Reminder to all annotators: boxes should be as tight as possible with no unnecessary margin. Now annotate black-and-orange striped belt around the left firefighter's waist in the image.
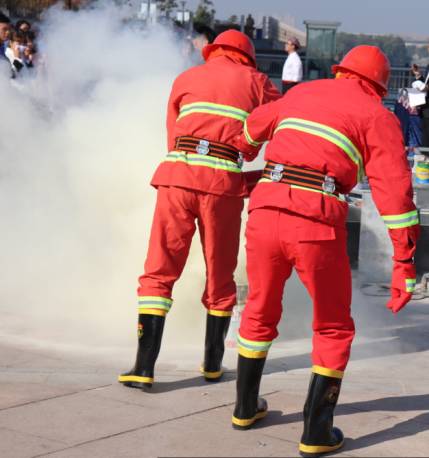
[176,136,241,164]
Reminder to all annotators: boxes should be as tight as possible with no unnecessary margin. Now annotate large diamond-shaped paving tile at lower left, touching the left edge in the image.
[0,391,164,445]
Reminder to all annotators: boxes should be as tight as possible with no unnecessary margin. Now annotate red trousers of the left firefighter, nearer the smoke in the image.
[138,186,243,316]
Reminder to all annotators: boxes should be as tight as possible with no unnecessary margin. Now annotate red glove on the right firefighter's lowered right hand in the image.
[386,261,416,313]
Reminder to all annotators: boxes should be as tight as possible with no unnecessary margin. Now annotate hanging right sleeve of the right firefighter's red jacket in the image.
[365,110,420,262]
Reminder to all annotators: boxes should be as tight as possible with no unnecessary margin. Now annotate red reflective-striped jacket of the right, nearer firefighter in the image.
[234,78,419,260]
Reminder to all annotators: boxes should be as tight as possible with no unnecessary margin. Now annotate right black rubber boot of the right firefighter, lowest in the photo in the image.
[299,373,344,457]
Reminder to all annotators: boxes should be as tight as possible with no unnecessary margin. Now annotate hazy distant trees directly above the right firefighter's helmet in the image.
[337,32,410,67]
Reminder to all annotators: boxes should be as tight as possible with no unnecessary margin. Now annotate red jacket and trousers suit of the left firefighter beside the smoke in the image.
[138,49,280,316]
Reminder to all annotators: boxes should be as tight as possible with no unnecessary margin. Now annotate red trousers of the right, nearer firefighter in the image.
[238,208,355,377]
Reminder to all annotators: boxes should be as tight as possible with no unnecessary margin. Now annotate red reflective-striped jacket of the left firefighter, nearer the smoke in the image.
[151,56,281,196]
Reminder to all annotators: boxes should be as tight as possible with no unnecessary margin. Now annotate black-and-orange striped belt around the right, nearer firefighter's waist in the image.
[262,161,339,196]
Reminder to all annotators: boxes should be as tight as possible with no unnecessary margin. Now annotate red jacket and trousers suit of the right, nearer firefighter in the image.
[235,79,419,377]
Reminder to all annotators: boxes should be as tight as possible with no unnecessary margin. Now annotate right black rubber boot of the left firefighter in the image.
[201,314,231,382]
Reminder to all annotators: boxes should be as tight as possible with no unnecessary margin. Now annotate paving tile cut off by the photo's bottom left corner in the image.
[0,428,64,458]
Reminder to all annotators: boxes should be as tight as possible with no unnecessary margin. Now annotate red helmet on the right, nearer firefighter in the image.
[332,45,390,95]
